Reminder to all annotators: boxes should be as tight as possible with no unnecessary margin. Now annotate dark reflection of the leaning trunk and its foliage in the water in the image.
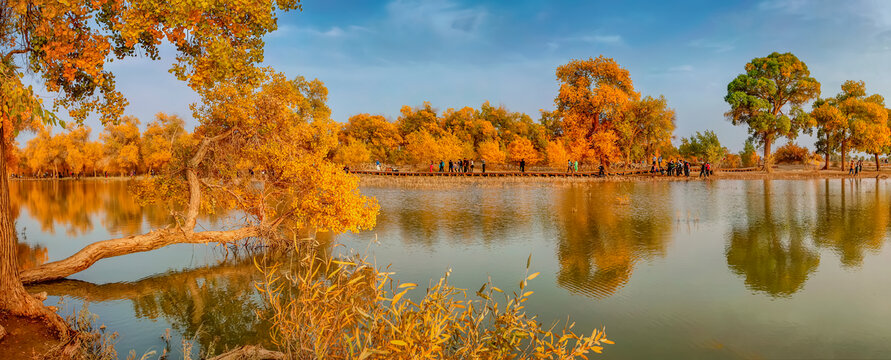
[28,257,270,349]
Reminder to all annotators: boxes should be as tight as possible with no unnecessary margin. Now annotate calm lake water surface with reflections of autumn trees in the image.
[11,179,891,359]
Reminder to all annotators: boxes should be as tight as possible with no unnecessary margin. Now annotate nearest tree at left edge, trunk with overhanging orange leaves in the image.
[0,0,300,335]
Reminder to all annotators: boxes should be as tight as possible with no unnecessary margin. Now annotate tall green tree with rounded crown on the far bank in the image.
[724,52,820,172]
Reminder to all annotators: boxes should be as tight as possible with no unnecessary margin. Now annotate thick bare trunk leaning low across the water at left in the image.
[20,226,260,284]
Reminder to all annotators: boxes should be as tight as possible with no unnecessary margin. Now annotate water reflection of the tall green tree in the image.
[726,180,820,296]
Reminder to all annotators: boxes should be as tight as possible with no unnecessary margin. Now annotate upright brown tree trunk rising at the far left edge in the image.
[0,126,68,337]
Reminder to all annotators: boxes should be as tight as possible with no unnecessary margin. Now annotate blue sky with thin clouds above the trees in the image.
[22,0,891,150]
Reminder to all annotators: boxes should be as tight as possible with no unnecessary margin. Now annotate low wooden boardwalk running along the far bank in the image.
[349,167,757,178]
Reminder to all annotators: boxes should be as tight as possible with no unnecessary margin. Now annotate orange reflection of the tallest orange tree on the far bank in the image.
[554,183,672,298]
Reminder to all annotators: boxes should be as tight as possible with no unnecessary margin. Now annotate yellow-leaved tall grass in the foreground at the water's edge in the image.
[256,240,613,359]
